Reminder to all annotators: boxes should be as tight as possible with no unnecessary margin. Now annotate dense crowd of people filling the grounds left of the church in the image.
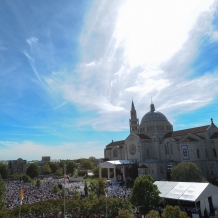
[5,178,131,210]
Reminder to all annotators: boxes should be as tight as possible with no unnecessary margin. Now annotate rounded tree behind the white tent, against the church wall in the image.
[171,162,202,182]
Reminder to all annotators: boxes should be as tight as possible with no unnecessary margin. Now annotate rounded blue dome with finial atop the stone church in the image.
[140,103,169,125]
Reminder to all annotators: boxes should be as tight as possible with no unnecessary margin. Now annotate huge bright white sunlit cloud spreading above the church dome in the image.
[43,0,218,130]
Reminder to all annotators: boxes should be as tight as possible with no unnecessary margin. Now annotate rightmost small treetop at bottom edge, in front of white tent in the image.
[161,205,189,218]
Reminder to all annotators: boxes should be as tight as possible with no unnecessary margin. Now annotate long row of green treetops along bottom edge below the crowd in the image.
[6,197,132,218]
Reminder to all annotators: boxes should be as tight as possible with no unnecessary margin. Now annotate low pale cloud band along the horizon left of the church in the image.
[0,141,103,160]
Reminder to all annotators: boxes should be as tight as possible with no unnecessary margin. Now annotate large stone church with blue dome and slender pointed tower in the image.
[104,102,218,180]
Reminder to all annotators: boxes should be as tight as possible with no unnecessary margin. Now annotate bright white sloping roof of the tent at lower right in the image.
[154,181,218,202]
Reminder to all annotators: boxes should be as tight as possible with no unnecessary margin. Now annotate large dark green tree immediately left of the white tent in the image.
[130,175,161,214]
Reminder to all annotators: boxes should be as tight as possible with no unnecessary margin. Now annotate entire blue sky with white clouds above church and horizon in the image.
[0,0,218,160]
